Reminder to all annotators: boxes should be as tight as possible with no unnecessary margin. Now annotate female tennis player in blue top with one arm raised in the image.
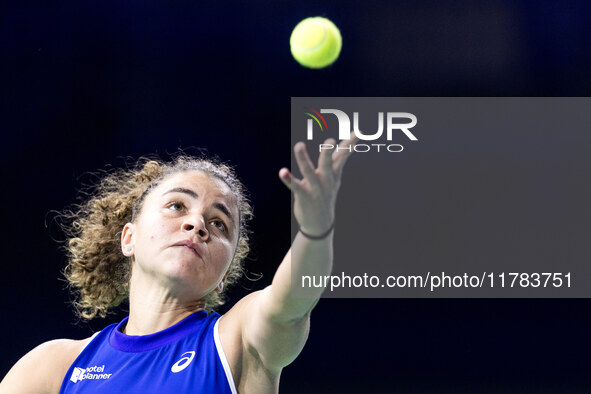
[0,139,353,394]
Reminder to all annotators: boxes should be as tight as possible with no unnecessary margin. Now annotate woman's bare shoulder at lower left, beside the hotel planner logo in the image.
[0,337,92,394]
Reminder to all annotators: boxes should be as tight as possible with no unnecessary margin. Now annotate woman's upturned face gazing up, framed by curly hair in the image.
[122,171,239,299]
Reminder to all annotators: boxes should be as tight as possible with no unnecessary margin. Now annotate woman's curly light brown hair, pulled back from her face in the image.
[61,155,252,320]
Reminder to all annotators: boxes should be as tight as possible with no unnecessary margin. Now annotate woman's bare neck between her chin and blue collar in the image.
[123,275,205,335]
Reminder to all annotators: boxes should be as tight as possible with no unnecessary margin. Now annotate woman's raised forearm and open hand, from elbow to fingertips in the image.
[263,136,355,322]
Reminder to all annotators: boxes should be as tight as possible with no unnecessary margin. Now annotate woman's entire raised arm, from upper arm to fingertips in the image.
[234,139,354,374]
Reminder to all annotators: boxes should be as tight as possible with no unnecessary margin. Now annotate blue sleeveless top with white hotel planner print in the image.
[60,311,236,394]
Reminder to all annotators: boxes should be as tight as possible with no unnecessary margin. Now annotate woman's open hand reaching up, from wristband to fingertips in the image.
[279,133,357,236]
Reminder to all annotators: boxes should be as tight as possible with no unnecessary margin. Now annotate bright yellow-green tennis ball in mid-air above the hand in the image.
[289,17,343,68]
